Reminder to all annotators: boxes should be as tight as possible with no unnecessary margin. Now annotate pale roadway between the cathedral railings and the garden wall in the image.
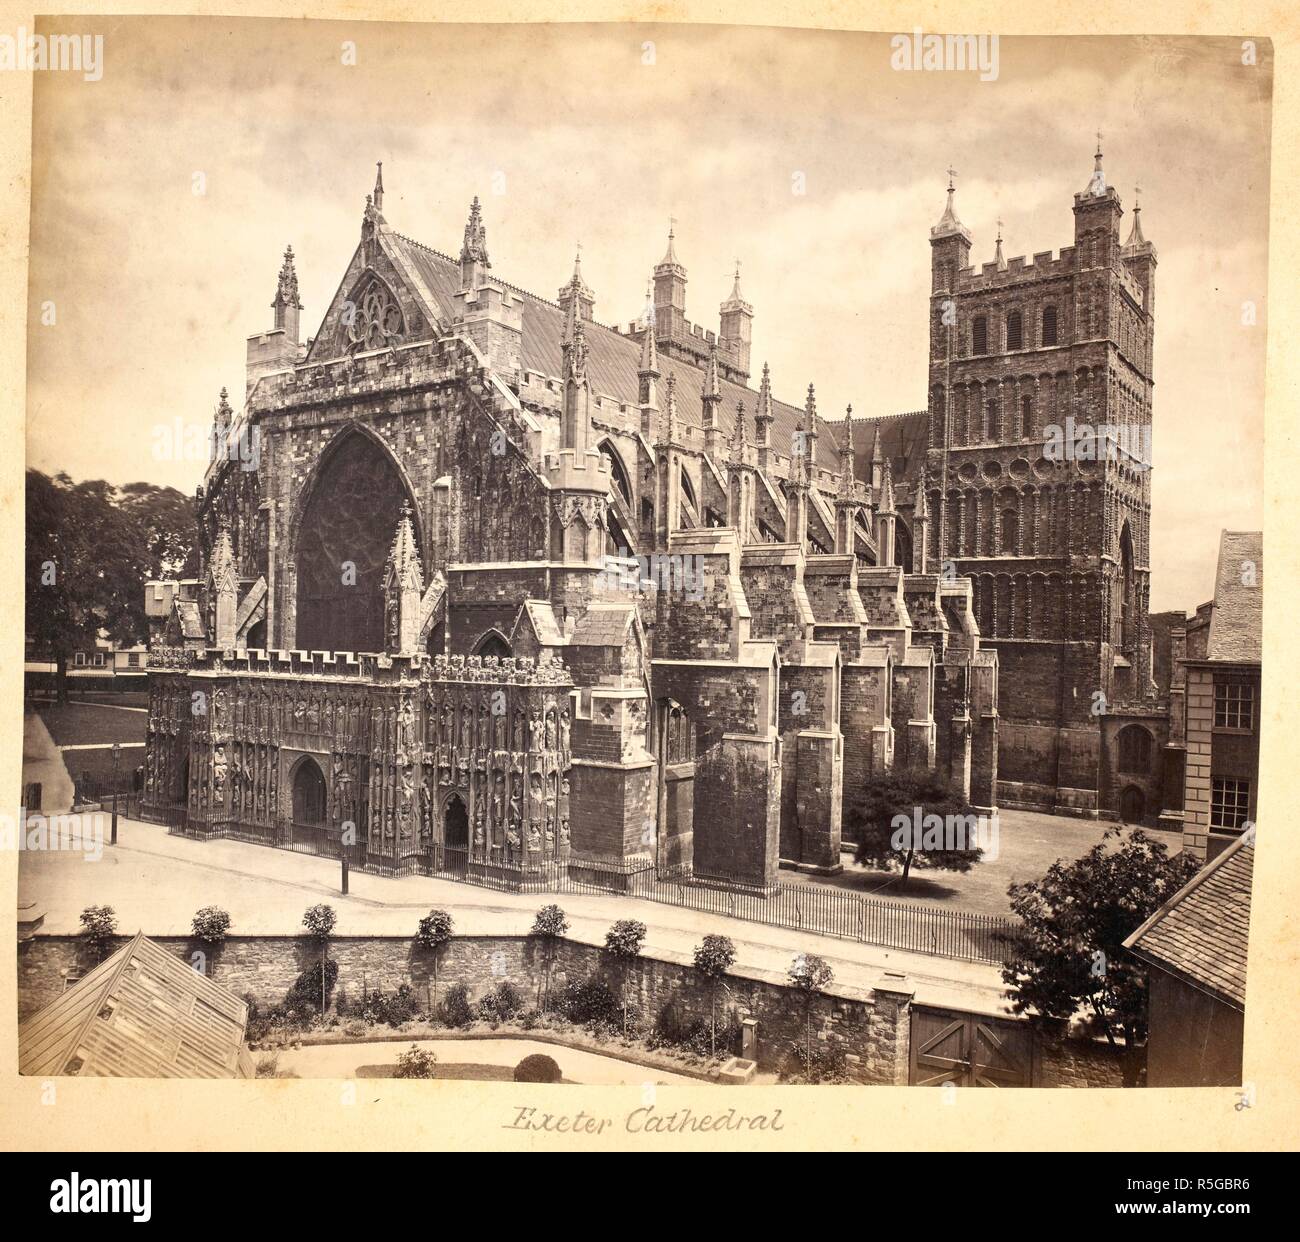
[18,817,1004,1013]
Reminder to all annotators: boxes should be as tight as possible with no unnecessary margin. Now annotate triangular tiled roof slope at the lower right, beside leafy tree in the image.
[1125,835,1255,1009]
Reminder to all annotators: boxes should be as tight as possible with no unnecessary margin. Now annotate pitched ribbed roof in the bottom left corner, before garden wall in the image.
[18,934,251,1078]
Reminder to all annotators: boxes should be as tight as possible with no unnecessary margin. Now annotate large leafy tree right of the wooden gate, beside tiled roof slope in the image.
[1002,826,1196,1083]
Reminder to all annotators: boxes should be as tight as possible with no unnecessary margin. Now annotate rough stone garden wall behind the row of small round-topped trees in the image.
[18,935,1121,1086]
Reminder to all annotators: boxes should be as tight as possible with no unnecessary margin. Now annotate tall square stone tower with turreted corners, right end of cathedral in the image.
[924,145,1156,812]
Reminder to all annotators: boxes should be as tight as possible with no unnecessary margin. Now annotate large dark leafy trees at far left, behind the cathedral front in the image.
[25,469,198,702]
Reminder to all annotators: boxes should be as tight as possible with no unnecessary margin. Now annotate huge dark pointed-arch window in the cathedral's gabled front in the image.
[294,430,408,653]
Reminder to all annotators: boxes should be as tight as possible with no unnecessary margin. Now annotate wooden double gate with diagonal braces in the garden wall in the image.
[907,1005,1035,1087]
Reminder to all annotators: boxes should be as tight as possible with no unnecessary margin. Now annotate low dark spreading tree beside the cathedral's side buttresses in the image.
[845,769,983,888]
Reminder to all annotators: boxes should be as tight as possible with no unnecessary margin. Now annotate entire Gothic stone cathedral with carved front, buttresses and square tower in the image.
[143,151,1160,892]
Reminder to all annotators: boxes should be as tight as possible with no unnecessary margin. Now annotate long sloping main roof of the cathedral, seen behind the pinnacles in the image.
[393,233,840,471]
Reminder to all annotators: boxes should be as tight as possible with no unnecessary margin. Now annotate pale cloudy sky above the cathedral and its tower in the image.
[29,18,1271,609]
